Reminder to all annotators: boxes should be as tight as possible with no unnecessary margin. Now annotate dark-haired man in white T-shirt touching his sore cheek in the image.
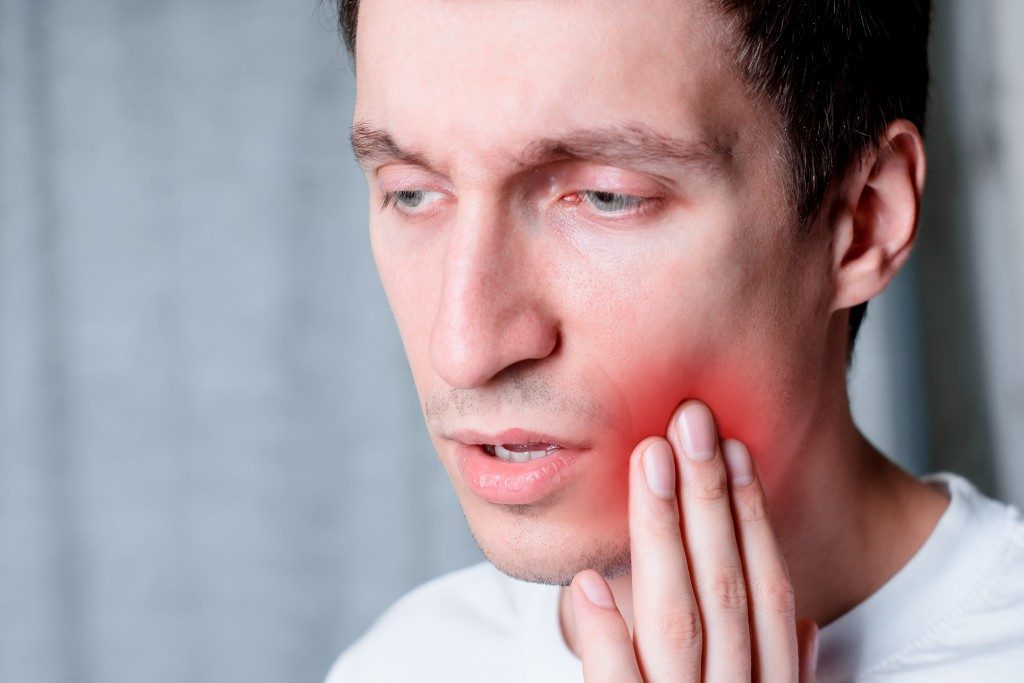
[329,0,1024,683]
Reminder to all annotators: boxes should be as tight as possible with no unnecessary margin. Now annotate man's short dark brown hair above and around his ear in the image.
[337,0,932,366]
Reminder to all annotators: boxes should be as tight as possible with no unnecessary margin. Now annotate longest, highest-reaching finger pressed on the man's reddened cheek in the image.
[669,400,752,681]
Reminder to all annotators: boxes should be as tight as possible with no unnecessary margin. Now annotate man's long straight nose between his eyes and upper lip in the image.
[430,200,558,389]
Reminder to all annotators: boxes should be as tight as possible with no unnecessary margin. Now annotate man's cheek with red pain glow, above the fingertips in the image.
[578,232,795,462]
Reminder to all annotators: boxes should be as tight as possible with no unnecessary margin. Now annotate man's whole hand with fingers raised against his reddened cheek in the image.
[571,400,817,683]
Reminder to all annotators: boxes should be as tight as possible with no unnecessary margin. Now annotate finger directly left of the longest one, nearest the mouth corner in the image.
[630,437,701,683]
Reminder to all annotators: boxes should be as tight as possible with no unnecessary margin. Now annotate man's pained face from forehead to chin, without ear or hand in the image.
[354,0,835,584]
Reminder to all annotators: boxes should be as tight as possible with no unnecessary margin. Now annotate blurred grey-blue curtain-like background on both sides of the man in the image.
[0,0,1024,683]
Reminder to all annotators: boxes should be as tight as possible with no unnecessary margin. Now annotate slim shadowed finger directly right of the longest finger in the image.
[722,439,799,681]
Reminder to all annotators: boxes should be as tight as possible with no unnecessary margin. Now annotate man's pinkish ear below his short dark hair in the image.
[830,120,926,311]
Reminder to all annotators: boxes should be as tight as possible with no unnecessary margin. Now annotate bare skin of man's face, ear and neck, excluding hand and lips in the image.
[353,0,946,667]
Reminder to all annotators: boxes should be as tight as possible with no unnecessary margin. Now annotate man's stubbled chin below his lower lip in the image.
[467,506,630,586]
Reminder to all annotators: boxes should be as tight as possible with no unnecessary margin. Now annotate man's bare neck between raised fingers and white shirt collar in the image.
[559,391,948,653]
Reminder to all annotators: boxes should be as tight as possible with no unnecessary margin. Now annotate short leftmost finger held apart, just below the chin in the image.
[570,569,643,683]
